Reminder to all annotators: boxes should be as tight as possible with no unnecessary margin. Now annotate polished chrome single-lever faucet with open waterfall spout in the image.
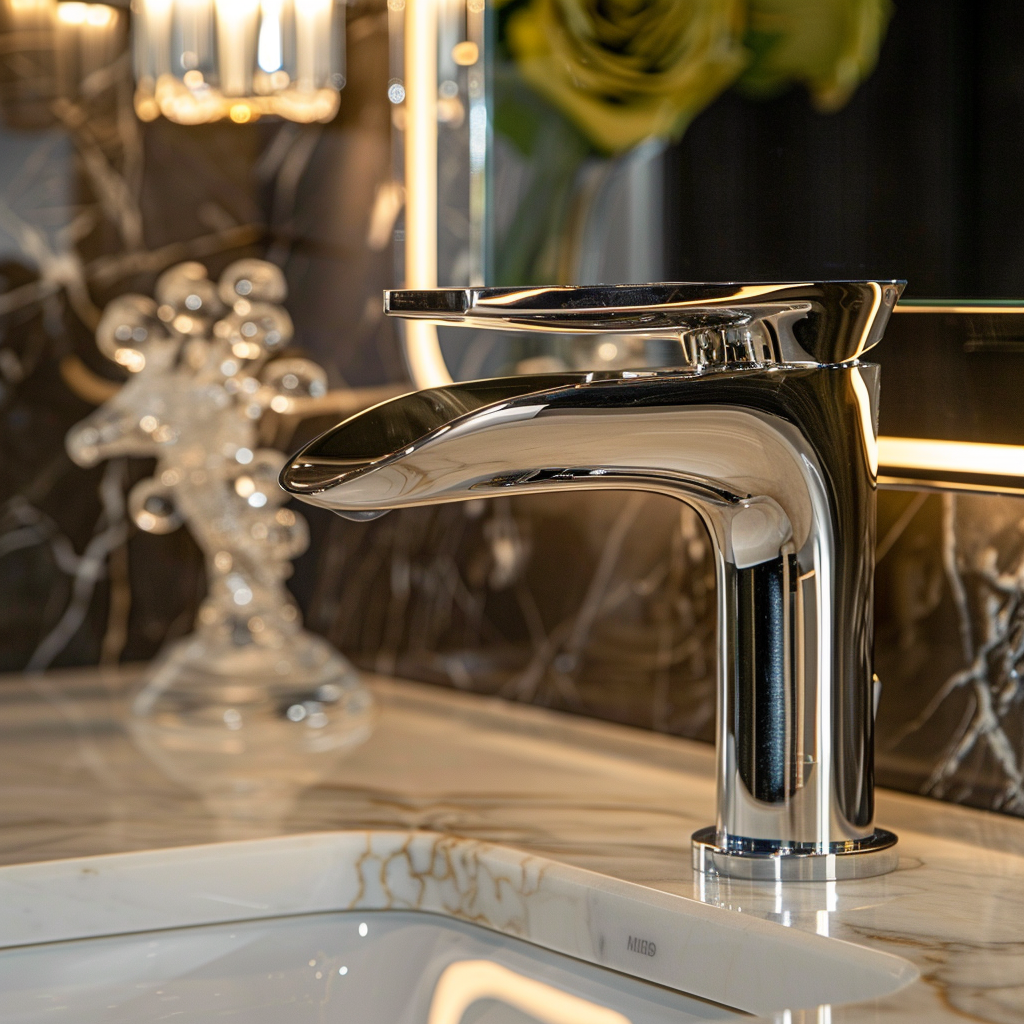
[281,281,903,881]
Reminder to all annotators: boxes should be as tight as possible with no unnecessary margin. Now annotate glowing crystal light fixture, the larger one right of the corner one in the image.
[132,0,345,124]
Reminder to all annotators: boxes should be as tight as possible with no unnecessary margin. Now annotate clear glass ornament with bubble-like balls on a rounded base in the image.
[68,259,372,818]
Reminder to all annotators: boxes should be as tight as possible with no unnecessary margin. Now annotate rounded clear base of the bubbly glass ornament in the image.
[129,615,374,822]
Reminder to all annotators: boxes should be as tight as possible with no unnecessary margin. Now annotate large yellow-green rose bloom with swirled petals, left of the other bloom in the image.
[506,0,749,154]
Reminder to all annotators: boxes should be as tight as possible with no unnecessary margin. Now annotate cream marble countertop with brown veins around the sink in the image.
[0,671,1024,1024]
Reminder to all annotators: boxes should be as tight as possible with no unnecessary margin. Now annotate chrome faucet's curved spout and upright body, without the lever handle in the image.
[282,365,892,877]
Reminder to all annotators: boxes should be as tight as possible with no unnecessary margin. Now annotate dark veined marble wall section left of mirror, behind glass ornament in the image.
[0,0,404,670]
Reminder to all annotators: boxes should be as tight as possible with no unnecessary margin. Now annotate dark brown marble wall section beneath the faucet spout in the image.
[309,494,715,739]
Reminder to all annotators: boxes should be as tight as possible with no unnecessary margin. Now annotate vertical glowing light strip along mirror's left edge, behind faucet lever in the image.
[404,0,452,388]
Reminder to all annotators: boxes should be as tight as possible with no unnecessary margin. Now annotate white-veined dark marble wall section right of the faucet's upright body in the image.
[876,493,1024,814]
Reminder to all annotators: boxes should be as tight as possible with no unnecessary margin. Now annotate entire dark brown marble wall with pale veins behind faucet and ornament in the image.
[0,0,1024,814]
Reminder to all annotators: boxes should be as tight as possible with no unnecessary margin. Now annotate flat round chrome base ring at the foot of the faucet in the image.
[692,826,899,882]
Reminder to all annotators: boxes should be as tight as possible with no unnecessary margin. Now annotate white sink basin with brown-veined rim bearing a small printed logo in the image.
[0,833,918,1024]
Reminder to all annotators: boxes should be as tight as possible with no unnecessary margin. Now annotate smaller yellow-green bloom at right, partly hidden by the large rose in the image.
[740,0,892,112]
